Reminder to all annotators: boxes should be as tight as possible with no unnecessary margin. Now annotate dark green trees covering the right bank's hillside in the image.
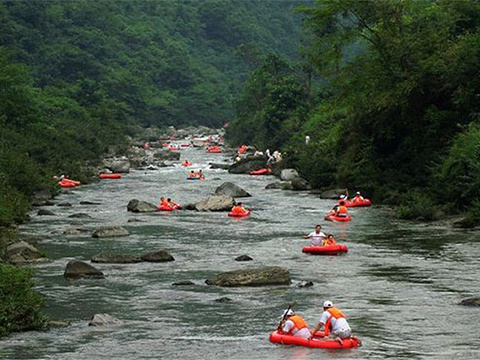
[229,0,480,226]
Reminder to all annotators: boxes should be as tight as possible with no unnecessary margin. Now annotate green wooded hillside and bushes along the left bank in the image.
[0,0,302,336]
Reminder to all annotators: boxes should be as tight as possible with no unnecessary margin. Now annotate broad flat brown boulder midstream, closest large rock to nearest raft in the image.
[205,266,291,287]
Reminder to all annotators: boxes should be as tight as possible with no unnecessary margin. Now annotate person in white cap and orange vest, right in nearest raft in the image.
[310,300,360,345]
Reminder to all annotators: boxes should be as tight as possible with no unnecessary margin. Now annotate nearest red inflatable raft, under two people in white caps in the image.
[270,330,360,349]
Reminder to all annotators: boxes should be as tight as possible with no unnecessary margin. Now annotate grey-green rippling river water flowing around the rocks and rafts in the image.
[0,148,480,360]
